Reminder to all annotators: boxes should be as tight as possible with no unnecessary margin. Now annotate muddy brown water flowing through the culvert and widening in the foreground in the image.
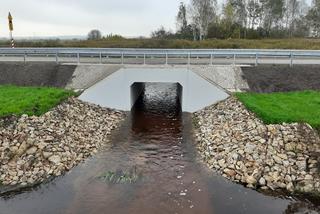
[0,84,317,214]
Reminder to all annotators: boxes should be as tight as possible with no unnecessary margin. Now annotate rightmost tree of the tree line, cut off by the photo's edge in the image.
[307,0,320,37]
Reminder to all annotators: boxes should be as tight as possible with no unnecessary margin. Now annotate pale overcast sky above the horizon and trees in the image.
[0,0,310,37]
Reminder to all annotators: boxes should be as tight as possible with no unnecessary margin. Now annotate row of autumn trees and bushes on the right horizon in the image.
[151,0,320,40]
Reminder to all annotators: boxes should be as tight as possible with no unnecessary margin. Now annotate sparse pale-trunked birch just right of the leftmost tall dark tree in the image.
[189,0,217,40]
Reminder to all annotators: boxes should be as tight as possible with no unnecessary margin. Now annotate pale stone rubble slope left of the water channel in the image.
[0,98,124,186]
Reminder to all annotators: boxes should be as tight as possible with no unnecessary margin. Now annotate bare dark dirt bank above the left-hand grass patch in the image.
[0,62,76,88]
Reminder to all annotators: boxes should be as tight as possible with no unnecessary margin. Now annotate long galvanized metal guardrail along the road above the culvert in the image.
[0,48,320,66]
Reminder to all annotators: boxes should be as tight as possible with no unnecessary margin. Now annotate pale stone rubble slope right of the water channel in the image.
[194,97,320,193]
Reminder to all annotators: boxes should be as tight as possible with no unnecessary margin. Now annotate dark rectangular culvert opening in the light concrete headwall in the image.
[131,82,183,117]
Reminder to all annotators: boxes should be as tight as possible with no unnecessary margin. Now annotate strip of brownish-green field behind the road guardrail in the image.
[0,38,320,50]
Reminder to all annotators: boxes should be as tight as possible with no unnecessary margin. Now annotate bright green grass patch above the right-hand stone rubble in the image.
[236,91,320,130]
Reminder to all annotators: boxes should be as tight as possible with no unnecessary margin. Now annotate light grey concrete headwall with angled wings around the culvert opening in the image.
[80,67,228,112]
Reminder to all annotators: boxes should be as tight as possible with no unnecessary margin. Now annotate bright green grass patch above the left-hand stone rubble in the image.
[0,86,75,117]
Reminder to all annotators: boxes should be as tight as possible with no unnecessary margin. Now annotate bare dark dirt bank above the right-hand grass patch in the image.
[242,65,320,93]
